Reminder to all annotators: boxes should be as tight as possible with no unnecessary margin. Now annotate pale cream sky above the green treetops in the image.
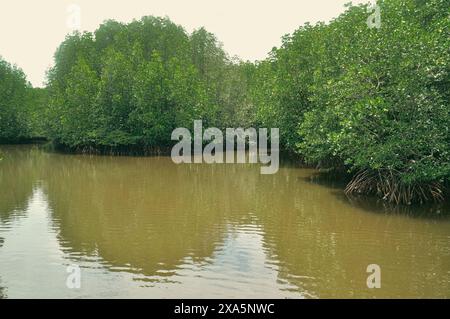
[0,0,368,86]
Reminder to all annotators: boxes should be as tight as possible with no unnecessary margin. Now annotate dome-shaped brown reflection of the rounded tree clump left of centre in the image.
[45,156,262,275]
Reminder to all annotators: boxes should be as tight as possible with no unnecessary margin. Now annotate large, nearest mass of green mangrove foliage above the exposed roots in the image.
[251,0,450,202]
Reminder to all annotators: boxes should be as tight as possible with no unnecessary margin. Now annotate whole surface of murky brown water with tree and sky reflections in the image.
[0,146,450,298]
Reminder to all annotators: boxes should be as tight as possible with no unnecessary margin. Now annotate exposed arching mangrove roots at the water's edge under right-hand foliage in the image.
[345,170,444,205]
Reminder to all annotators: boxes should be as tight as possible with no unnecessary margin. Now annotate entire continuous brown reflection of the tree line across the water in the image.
[0,146,450,297]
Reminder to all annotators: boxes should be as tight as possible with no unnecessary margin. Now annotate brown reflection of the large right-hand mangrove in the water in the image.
[253,171,450,297]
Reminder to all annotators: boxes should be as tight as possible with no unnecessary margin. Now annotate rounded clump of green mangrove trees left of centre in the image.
[47,17,253,148]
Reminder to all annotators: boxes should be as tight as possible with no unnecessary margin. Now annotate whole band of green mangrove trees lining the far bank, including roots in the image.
[0,0,450,203]
